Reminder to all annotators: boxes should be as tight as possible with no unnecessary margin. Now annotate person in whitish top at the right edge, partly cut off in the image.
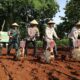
[68,21,80,58]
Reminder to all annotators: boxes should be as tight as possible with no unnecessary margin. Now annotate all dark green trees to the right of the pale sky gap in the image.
[58,0,80,37]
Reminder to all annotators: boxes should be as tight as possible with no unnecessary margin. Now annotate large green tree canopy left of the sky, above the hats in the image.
[0,0,59,38]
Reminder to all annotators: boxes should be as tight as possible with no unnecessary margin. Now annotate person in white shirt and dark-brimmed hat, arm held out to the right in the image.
[45,20,59,62]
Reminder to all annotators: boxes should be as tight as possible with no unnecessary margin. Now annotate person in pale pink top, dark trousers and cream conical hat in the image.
[25,20,39,56]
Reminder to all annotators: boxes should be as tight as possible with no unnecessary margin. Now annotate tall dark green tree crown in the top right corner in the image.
[65,0,80,25]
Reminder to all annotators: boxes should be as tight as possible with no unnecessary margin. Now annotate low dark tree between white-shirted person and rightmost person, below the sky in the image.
[57,17,72,38]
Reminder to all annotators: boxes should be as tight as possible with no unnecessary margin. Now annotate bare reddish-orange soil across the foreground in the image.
[0,49,80,80]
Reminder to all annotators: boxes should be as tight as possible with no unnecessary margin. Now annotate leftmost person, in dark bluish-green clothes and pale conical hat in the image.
[7,23,19,56]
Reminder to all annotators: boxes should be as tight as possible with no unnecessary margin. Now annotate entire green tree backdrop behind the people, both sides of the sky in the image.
[0,0,80,45]
